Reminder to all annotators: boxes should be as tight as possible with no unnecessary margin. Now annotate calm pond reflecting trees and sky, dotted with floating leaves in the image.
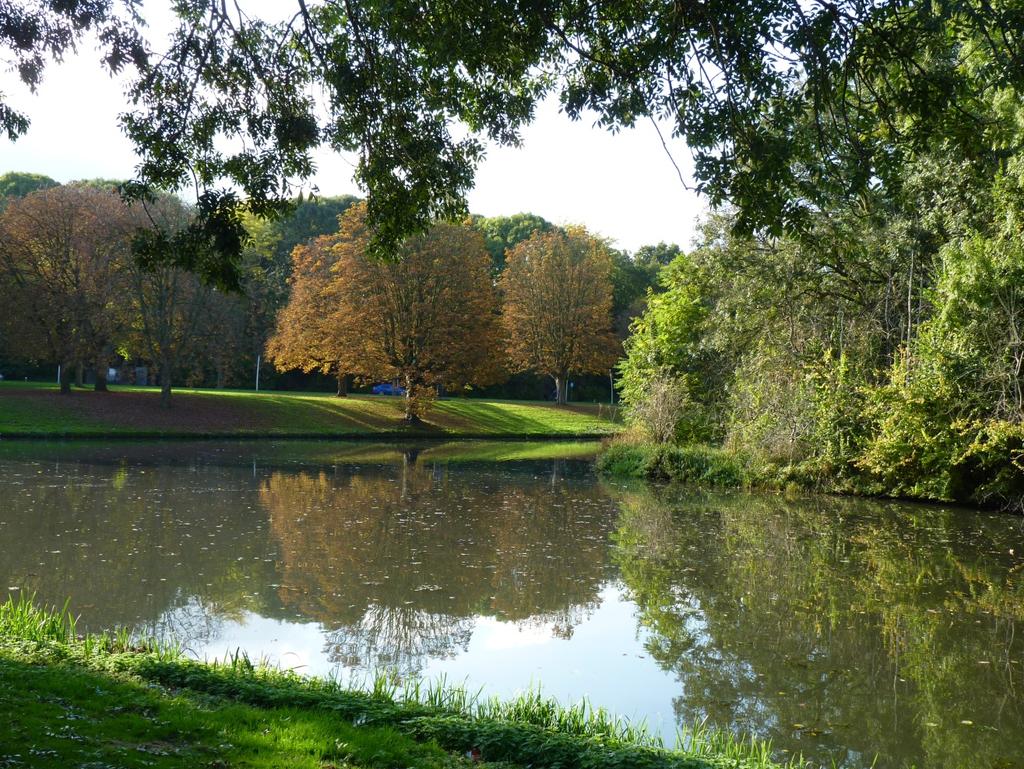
[0,443,1024,769]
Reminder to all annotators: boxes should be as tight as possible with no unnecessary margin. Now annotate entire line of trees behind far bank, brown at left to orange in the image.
[0,173,667,411]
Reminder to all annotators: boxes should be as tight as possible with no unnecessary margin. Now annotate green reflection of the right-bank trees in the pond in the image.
[615,492,1024,768]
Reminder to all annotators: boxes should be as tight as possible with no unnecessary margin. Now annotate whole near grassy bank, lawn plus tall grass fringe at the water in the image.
[0,599,804,769]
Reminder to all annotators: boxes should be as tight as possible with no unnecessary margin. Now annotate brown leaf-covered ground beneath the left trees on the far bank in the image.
[0,390,268,433]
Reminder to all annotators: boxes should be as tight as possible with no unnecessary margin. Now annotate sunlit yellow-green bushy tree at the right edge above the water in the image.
[859,208,1024,510]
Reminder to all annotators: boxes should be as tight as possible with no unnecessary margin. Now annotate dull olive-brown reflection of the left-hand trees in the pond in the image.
[0,463,273,643]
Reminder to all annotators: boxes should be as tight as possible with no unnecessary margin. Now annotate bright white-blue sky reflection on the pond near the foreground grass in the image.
[177,584,679,741]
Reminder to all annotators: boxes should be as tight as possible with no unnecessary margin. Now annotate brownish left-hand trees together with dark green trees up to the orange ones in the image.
[0,172,376,400]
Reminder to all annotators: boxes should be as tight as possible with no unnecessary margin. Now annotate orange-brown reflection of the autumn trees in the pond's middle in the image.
[260,460,614,671]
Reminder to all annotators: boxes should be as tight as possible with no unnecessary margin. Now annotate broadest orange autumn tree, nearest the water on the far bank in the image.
[267,204,504,422]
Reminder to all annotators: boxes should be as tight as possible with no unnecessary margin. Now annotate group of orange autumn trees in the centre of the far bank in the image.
[267,204,618,421]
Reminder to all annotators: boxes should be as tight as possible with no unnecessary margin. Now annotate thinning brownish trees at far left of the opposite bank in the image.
[0,181,235,402]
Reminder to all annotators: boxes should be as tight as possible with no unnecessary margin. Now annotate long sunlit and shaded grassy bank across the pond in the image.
[0,382,618,438]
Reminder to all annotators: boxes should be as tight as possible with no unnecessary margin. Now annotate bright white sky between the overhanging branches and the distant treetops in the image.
[0,19,705,251]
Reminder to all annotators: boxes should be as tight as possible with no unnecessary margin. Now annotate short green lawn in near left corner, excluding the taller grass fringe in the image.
[0,651,491,769]
